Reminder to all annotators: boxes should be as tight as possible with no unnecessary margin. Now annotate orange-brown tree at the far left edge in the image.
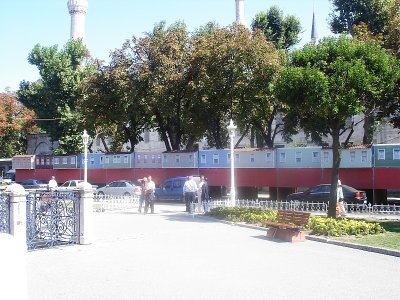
[0,93,39,157]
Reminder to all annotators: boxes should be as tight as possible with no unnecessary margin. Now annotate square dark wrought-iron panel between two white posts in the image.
[26,191,80,250]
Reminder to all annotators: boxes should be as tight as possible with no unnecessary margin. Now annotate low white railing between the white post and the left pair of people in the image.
[93,194,139,212]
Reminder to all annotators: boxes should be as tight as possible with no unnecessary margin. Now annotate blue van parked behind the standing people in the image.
[155,176,200,202]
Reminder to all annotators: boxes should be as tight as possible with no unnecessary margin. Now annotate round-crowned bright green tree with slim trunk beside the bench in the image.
[276,36,399,217]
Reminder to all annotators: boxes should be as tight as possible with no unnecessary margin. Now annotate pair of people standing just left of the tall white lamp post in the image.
[183,176,210,213]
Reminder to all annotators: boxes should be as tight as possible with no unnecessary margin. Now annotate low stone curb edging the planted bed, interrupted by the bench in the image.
[196,216,400,257]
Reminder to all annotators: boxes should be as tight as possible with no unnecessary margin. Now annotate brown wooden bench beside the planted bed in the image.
[263,210,310,242]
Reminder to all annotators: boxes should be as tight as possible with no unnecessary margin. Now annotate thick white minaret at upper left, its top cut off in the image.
[67,0,88,40]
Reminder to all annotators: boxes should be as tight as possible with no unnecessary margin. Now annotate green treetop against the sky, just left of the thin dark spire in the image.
[251,6,301,50]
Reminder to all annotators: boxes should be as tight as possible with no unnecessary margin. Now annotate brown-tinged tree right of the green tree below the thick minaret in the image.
[82,49,152,152]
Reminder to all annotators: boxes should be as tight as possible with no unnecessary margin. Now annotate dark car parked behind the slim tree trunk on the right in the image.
[286,184,367,204]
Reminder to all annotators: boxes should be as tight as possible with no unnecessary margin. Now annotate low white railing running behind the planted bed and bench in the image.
[197,200,400,215]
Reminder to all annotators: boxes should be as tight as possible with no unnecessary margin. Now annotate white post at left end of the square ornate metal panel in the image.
[6,183,28,249]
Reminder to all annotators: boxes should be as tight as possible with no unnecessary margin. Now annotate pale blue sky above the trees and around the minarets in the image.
[0,0,331,92]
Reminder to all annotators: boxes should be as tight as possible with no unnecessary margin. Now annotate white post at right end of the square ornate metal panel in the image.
[78,183,94,245]
